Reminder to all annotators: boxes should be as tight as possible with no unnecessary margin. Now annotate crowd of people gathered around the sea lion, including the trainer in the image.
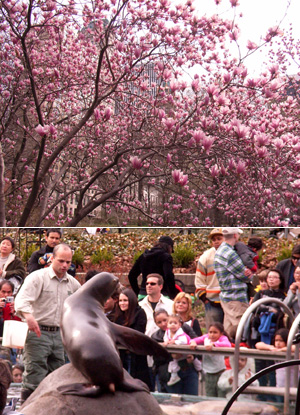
[0,231,300,413]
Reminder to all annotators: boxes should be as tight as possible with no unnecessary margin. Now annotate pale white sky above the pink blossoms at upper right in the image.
[194,0,300,74]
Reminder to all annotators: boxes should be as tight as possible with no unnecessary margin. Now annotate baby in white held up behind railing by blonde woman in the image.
[164,314,190,386]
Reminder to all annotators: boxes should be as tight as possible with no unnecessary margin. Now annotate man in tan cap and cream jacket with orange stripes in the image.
[195,228,224,329]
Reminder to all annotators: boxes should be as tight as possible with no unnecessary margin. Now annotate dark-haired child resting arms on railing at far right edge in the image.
[255,328,297,402]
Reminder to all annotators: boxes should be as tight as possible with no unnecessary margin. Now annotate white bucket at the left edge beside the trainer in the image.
[2,320,28,349]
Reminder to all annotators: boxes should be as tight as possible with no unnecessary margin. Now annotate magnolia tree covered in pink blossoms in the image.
[0,0,300,226]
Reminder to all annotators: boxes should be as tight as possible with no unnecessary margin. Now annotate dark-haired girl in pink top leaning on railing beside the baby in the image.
[190,322,231,396]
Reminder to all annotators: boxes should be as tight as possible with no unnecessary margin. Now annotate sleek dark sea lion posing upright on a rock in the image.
[59,272,168,396]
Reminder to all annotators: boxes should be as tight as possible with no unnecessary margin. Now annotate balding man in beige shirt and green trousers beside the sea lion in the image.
[15,244,80,403]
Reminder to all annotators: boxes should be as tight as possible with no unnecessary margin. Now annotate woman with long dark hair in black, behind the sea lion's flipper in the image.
[114,288,151,388]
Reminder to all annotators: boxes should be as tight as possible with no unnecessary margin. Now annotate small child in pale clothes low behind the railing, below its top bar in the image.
[218,347,259,401]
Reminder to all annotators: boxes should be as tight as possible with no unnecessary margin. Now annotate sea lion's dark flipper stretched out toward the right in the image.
[111,323,169,358]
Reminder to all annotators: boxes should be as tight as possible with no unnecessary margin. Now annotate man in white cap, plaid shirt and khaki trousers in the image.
[214,227,252,338]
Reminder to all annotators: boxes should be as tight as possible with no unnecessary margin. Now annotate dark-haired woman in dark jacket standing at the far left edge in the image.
[0,236,26,294]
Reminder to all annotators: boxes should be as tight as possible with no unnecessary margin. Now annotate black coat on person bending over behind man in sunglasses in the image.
[128,247,178,299]
